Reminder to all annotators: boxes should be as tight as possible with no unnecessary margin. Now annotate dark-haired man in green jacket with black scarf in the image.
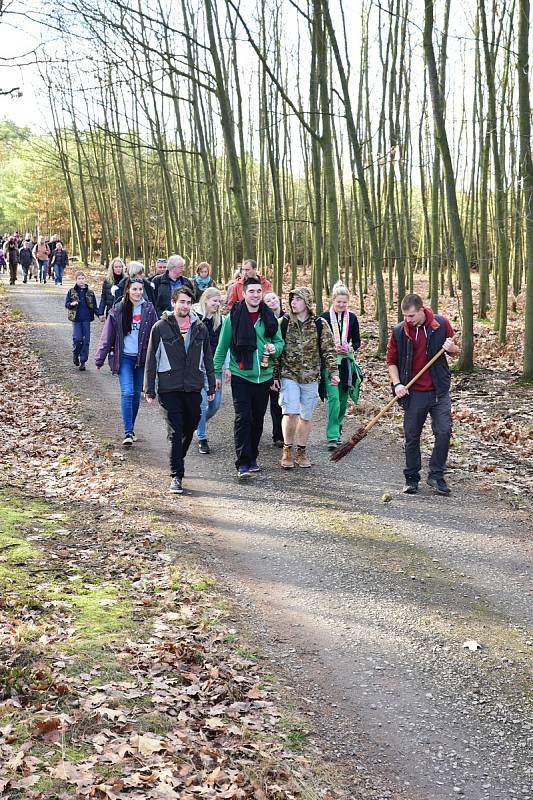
[215,277,283,479]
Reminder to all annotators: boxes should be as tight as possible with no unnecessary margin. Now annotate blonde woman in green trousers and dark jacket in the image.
[322,282,362,450]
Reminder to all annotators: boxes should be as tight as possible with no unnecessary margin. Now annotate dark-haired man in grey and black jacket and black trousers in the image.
[144,286,215,494]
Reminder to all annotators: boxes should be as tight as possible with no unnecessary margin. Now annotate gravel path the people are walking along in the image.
[11,276,533,800]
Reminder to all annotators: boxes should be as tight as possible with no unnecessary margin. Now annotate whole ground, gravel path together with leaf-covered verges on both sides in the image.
[0,270,533,800]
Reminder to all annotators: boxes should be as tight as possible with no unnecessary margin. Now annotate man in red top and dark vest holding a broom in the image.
[387,294,460,495]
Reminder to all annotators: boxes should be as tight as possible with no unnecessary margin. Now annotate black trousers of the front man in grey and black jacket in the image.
[159,392,202,478]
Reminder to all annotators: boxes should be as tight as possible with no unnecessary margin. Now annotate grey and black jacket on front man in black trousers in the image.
[144,312,215,397]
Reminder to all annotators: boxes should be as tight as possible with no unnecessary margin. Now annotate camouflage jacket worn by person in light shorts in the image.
[279,314,339,383]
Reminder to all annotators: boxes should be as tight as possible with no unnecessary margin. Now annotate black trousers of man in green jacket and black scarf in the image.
[231,375,271,469]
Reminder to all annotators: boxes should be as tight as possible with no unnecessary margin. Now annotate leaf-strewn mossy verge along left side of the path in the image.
[0,297,344,800]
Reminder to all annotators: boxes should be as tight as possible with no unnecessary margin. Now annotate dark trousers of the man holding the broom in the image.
[403,390,452,481]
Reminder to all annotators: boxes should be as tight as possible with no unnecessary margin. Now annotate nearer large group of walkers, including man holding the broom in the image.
[2,237,459,495]
